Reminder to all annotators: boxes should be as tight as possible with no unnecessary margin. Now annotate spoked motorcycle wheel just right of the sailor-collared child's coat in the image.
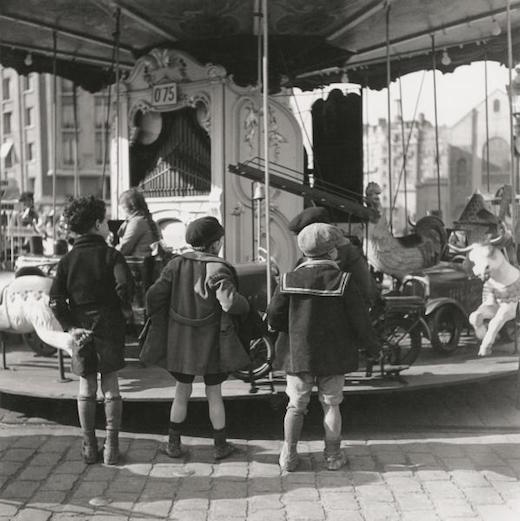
[379,317,422,365]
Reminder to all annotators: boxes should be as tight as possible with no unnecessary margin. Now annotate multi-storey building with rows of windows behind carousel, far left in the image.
[0,69,111,211]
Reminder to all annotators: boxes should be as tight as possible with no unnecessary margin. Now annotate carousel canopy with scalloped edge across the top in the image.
[0,0,520,91]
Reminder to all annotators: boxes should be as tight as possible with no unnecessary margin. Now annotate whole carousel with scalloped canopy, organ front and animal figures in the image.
[0,0,520,401]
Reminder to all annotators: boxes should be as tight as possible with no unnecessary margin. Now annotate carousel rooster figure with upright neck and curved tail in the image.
[365,182,447,279]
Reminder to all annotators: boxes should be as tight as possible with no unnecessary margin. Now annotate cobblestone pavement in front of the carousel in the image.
[0,378,520,521]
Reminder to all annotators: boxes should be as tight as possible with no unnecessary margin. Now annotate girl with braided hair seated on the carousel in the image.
[116,188,161,257]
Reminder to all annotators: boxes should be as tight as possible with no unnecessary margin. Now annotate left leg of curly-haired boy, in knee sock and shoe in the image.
[78,373,98,464]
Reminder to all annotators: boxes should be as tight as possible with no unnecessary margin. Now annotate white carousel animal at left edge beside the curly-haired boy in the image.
[0,275,74,355]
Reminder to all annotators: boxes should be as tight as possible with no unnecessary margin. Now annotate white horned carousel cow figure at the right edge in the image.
[450,237,520,356]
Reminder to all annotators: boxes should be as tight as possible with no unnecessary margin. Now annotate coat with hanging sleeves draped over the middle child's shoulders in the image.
[141,251,249,376]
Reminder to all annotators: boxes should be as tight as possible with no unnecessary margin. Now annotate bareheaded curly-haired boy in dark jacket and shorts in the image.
[50,196,133,465]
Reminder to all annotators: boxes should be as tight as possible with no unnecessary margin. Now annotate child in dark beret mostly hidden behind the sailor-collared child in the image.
[289,206,378,306]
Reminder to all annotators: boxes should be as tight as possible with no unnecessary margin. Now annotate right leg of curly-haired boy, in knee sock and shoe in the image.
[101,371,123,465]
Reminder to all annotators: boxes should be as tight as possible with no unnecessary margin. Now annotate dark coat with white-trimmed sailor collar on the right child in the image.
[268,260,379,376]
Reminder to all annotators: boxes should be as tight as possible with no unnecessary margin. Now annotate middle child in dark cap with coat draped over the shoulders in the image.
[143,217,249,460]
